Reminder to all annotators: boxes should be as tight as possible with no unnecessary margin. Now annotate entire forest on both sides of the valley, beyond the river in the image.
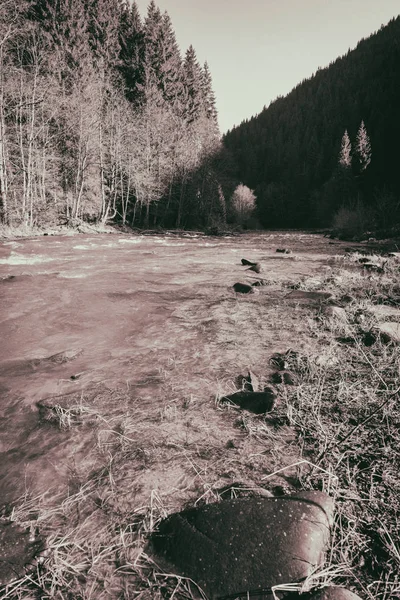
[0,0,400,229]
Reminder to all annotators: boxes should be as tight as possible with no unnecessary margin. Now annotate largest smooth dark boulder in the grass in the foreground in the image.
[147,491,334,600]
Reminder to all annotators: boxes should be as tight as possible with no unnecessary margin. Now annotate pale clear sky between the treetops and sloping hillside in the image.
[136,0,400,133]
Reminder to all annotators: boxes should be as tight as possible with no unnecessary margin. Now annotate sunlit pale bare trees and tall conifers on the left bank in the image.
[0,0,239,227]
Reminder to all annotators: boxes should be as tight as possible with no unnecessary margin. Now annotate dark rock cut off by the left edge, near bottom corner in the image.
[0,520,45,585]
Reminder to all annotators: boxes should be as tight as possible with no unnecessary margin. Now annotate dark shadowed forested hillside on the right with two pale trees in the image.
[223,17,400,229]
